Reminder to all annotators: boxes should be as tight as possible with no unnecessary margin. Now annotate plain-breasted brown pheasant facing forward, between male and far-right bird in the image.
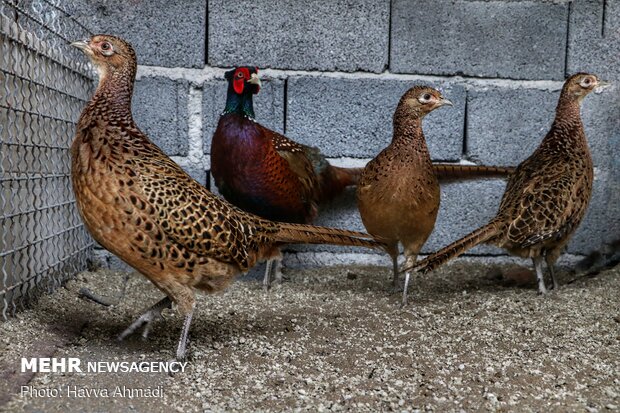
[357,86,452,306]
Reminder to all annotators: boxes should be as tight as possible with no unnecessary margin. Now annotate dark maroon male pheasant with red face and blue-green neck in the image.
[211,66,513,289]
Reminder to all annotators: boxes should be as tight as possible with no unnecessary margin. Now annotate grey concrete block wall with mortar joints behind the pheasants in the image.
[70,0,620,268]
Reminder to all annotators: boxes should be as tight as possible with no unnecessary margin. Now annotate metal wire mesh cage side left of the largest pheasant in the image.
[0,0,94,319]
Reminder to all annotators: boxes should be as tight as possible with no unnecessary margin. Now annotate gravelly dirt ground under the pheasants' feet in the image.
[0,262,620,412]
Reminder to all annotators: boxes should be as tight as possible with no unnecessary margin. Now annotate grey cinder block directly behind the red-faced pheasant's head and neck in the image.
[202,77,284,153]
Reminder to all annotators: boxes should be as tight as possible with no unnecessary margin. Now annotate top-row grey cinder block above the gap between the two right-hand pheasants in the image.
[390,0,568,79]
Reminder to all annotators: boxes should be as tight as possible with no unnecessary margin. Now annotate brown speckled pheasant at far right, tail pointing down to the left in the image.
[407,73,607,294]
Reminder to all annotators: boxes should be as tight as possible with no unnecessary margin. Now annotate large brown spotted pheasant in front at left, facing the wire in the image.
[71,35,381,360]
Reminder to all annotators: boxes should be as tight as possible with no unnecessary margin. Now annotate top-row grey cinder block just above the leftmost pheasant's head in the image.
[66,0,207,68]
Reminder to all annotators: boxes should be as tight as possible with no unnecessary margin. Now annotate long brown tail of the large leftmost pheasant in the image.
[273,223,385,249]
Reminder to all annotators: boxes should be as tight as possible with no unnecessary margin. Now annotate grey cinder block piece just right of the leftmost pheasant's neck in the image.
[132,77,189,156]
